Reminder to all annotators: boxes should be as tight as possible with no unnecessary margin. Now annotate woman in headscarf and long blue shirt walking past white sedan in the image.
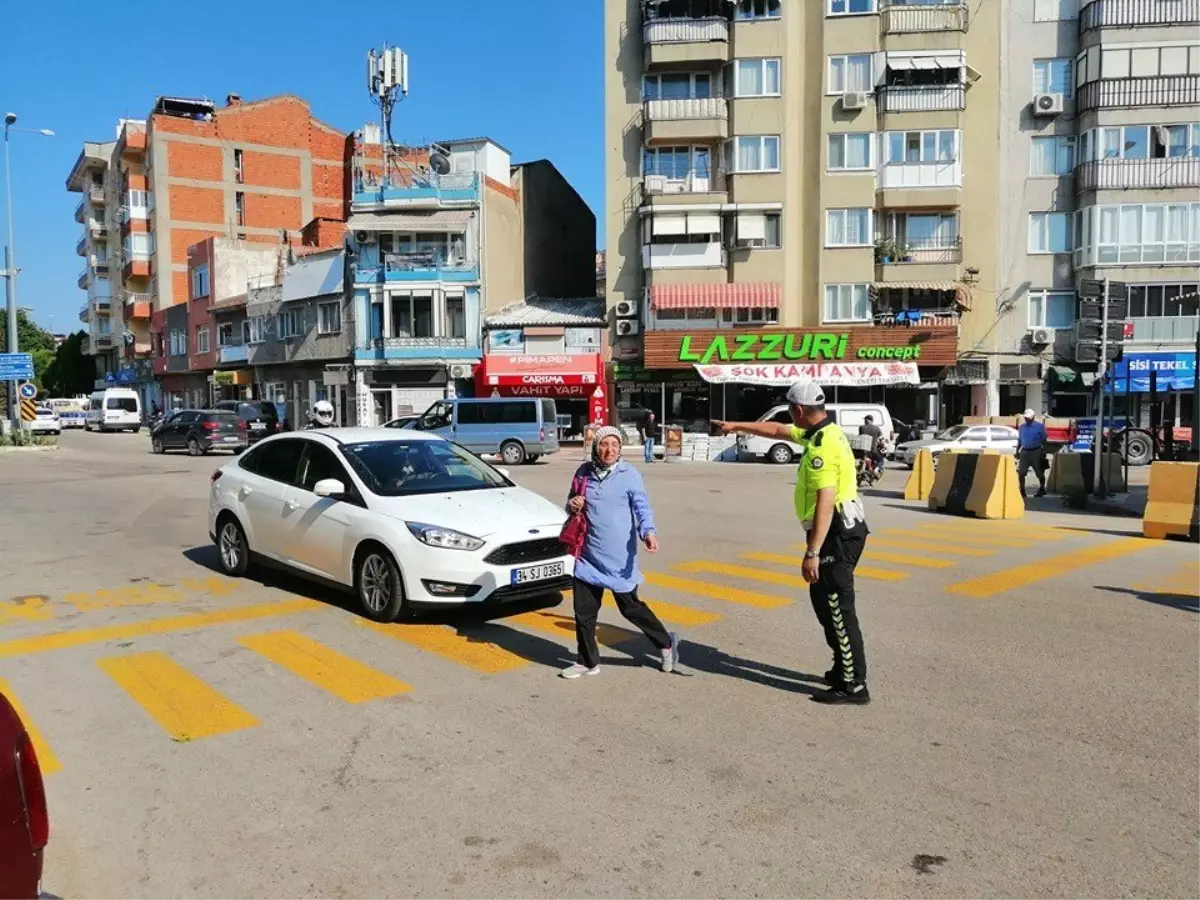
[559,425,679,678]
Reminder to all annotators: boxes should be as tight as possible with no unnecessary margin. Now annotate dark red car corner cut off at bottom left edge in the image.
[0,694,50,900]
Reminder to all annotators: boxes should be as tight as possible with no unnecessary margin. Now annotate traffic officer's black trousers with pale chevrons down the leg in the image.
[809,514,866,686]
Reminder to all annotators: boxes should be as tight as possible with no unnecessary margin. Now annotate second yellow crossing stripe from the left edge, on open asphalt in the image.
[96,650,258,742]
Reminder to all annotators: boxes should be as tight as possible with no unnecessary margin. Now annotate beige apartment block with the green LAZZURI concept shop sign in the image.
[605,0,1001,421]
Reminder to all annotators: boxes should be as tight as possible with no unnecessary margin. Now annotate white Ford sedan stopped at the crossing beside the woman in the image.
[209,428,575,622]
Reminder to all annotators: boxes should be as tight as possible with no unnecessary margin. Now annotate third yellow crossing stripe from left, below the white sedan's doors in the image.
[238,631,413,703]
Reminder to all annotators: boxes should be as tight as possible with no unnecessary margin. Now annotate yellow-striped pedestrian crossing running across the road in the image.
[0,520,1157,773]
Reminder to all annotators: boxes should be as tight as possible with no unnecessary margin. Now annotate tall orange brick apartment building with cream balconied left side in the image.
[67,94,348,408]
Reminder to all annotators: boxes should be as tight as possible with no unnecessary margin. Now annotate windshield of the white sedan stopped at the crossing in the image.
[342,440,512,497]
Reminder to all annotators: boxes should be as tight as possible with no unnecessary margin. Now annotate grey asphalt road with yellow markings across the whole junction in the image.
[0,433,1200,900]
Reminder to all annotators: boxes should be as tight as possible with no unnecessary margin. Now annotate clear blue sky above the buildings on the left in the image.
[0,0,604,331]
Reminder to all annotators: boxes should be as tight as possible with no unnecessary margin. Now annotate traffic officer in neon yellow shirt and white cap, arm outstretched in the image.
[714,382,871,704]
